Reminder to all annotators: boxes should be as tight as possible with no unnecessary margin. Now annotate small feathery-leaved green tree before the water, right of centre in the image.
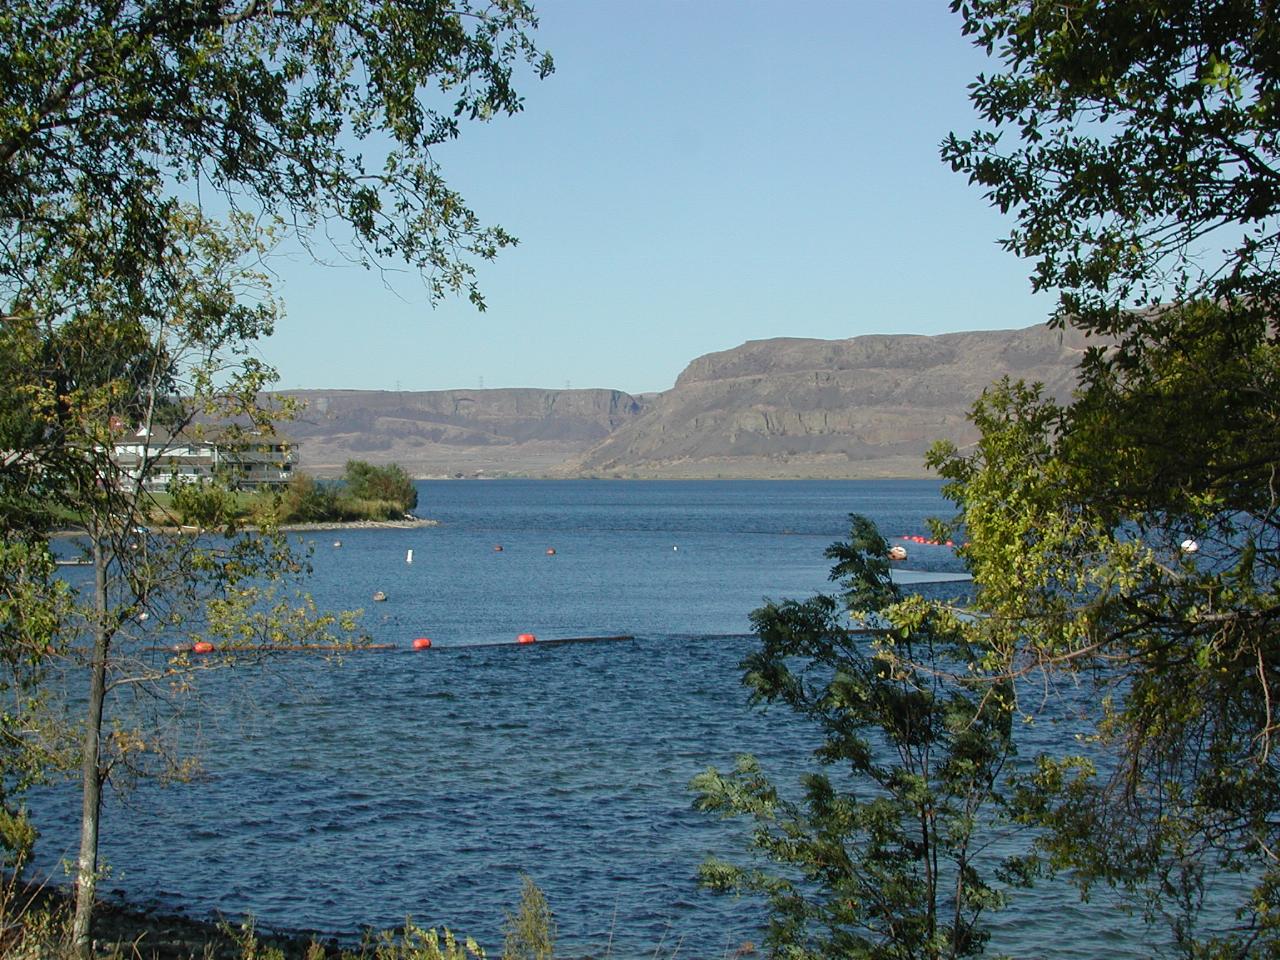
[691,516,1015,959]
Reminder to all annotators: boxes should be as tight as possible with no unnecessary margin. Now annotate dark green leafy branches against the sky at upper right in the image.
[942,0,1280,335]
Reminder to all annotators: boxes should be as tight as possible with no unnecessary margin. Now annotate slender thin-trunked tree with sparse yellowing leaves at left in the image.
[31,209,352,956]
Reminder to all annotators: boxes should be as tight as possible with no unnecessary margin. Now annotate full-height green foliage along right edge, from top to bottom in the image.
[931,0,1280,955]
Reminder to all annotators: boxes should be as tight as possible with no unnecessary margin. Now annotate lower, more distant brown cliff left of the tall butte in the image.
[284,389,646,476]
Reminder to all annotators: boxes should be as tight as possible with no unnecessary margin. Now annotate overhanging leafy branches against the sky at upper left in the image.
[0,0,552,316]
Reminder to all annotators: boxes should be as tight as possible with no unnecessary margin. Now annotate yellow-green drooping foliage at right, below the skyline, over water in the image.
[933,343,1280,948]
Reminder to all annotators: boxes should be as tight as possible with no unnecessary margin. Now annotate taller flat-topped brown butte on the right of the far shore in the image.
[557,326,1084,477]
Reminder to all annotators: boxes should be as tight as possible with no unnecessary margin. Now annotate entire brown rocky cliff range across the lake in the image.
[285,325,1085,479]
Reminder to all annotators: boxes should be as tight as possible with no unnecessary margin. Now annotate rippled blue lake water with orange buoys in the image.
[35,481,1182,957]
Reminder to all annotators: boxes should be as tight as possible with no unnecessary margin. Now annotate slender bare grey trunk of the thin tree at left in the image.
[72,530,111,960]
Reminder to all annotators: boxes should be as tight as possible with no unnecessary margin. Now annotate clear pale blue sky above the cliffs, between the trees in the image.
[254,0,1051,393]
